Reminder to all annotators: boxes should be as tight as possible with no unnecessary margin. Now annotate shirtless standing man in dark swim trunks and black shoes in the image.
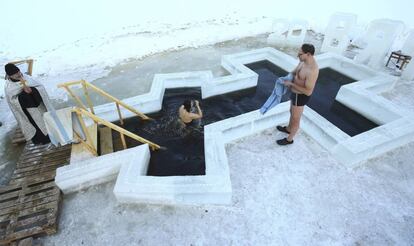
[276,44,319,145]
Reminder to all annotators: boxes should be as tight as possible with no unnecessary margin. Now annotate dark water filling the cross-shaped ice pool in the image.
[113,61,376,176]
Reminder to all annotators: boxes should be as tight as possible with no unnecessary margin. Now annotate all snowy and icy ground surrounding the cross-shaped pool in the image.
[0,0,414,245]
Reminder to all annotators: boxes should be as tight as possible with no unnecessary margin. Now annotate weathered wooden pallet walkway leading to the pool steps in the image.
[0,143,71,245]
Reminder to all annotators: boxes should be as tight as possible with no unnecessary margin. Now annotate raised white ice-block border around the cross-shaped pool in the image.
[57,48,414,204]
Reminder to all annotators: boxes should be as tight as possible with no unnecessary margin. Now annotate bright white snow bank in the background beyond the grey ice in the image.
[0,0,414,101]
